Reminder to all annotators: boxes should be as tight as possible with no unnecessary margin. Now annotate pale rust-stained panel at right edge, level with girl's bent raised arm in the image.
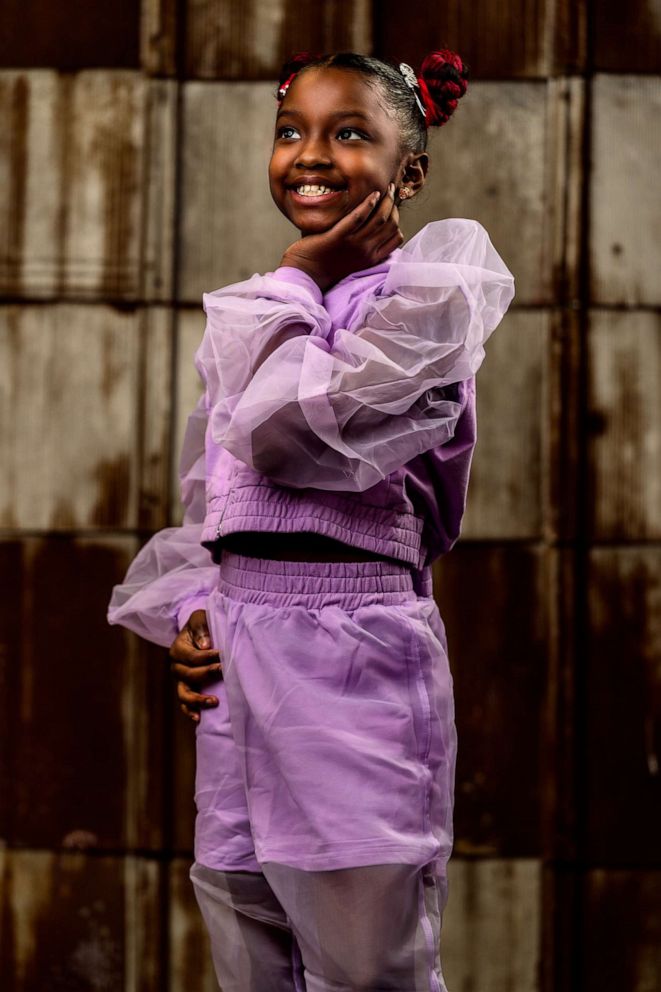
[589,310,661,540]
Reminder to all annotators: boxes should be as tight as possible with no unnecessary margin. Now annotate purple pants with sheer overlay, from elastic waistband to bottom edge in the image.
[191,552,456,992]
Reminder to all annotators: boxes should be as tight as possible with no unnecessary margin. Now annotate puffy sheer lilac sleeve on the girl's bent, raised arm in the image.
[196,218,514,492]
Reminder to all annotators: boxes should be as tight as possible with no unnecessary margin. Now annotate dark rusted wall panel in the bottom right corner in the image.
[582,872,661,992]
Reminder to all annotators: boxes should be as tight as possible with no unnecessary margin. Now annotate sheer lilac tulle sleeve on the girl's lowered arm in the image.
[108,396,218,647]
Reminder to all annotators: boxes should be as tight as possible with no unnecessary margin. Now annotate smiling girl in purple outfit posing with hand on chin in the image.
[109,51,514,992]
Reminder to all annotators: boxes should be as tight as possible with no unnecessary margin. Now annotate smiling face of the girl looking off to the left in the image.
[269,66,424,237]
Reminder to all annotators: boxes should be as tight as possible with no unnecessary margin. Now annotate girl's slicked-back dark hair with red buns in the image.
[275,48,470,153]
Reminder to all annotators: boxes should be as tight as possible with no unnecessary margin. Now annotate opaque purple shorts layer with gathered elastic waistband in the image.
[195,551,457,875]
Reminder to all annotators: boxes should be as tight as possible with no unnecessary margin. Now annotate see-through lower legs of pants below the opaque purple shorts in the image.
[190,862,447,992]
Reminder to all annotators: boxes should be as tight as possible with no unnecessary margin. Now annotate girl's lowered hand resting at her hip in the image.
[170,610,222,723]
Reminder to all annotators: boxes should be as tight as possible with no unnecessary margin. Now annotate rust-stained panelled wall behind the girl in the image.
[0,0,661,992]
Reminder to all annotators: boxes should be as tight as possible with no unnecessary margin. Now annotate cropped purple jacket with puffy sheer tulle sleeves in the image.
[108,218,514,646]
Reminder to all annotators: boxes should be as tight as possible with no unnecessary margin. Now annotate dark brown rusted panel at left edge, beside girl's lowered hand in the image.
[0,538,166,849]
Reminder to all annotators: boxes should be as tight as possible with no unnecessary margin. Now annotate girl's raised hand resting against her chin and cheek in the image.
[280,183,404,293]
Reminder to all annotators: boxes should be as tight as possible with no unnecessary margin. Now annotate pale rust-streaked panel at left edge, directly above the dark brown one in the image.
[0,303,170,530]
